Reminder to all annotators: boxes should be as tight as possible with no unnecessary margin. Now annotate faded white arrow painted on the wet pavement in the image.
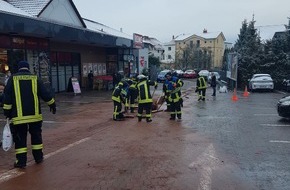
[189,144,220,190]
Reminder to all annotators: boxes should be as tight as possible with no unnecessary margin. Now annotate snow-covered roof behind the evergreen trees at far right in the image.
[256,24,286,41]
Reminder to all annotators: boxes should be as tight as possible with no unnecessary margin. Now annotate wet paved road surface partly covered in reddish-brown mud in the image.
[0,81,290,190]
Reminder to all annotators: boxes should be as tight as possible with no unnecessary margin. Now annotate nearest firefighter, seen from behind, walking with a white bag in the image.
[3,61,56,168]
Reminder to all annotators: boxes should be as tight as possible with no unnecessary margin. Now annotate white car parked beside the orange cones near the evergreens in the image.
[249,74,274,91]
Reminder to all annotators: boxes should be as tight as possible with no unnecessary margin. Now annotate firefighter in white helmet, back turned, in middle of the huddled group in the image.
[137,74,157,122]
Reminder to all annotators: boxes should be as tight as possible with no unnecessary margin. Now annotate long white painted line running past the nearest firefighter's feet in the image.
[0,137,91,184]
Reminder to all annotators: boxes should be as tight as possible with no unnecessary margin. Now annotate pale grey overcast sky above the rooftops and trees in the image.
[73,0,290,43]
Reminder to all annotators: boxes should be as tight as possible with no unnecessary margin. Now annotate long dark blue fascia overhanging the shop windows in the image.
[0,12,132,48]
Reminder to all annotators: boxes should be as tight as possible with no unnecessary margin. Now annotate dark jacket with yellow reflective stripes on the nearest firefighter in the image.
[3,70,55,125]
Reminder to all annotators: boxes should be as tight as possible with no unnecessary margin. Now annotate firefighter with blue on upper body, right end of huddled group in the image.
[163,73,184,120]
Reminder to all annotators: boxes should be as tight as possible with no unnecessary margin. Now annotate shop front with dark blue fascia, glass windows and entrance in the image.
[0,2,135,92]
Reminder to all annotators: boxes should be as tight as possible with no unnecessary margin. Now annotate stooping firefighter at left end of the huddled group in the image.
[112,81,127,121]
